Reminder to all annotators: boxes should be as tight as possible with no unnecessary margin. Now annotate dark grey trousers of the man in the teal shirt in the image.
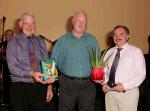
[59,75,96,111]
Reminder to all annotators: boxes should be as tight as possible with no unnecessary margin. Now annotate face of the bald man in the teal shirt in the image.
[73,13,87,34]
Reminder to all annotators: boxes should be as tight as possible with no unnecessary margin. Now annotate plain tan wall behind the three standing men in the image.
[0,0,150,53]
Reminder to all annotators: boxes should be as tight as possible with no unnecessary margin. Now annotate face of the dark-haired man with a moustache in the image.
[113,27,129,47]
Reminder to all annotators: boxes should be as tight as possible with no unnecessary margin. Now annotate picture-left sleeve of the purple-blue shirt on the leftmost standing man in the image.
[6,39,30,78]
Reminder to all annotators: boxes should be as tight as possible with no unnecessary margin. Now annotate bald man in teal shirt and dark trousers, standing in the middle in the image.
[51,11,99,111]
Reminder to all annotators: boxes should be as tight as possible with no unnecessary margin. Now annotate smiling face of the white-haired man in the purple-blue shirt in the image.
[19,16,35,36]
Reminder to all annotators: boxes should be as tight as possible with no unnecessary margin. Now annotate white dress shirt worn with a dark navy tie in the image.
[104,43,146,90]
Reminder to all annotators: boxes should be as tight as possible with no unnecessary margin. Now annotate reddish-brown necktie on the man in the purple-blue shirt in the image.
[28,37,38,71]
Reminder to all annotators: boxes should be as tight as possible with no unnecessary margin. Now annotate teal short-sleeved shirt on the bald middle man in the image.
[51,32,99,77]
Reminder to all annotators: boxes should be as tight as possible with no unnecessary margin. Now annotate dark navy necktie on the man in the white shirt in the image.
[107,48,122,87]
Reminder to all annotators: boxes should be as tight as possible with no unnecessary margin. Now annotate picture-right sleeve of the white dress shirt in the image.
[123,50,146,90]
